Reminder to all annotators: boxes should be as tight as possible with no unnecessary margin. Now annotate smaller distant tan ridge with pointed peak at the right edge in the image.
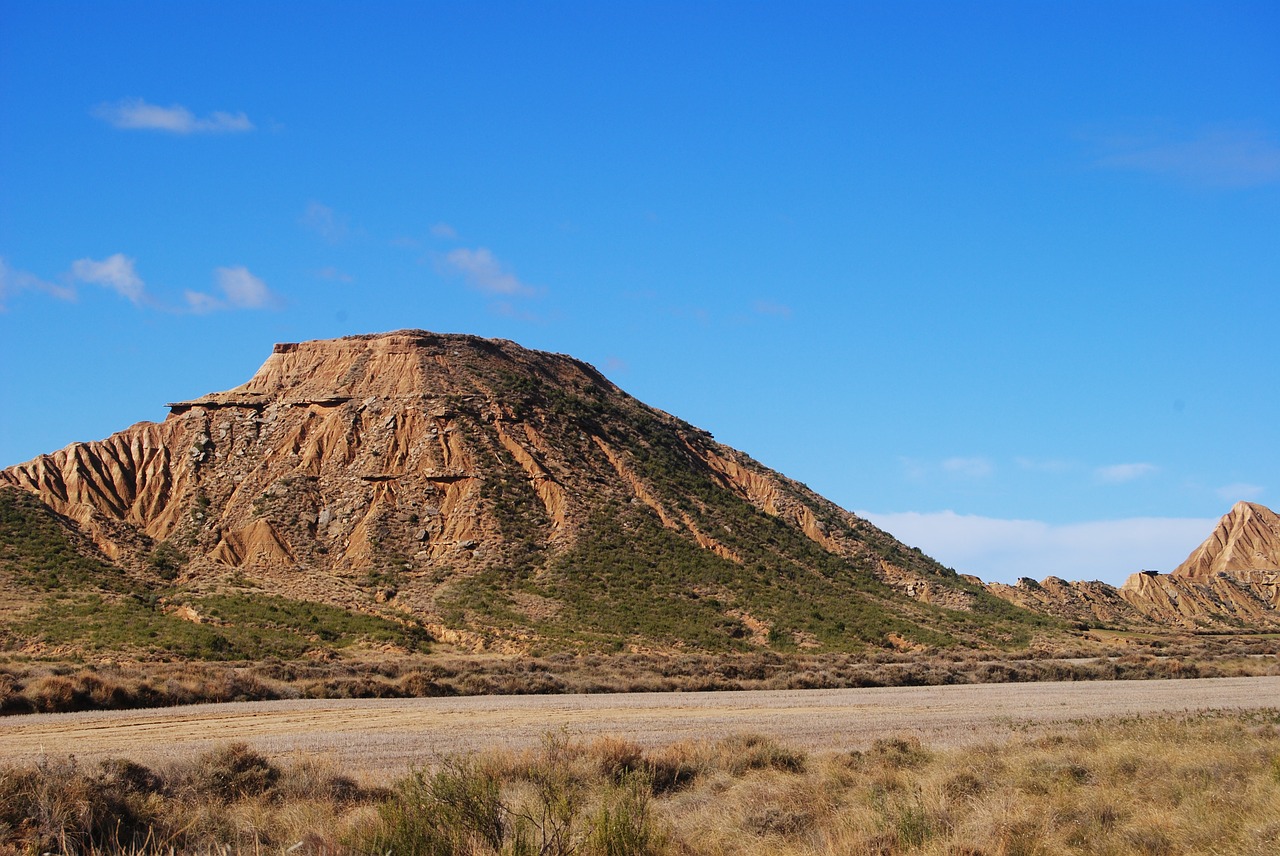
[988,502,1280,630]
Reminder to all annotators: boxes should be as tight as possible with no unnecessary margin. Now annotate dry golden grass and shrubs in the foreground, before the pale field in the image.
[0,710,1280,856]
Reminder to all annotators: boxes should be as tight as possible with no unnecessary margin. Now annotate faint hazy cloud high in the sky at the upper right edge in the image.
[1097,129,1280,188]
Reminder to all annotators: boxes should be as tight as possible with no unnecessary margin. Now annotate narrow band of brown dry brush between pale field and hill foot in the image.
[0,626,1280,714]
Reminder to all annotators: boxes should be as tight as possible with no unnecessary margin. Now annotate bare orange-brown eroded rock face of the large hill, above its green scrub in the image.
[0,330,968,632]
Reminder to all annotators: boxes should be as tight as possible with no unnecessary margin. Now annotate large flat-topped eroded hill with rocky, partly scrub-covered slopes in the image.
[0,330,1018,649]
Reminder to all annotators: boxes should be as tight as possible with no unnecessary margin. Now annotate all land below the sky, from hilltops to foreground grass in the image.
[0,330,1280,856]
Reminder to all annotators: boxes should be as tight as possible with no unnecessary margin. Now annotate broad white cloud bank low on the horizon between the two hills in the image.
[858,511,1217,586]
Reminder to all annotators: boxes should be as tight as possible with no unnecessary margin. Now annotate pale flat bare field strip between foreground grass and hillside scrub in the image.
[0,677,1280,778]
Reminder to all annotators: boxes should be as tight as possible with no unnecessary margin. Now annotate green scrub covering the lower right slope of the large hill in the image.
[440,489,1061,651]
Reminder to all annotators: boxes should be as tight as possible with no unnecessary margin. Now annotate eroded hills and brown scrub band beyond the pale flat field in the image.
[0,330,1280,713]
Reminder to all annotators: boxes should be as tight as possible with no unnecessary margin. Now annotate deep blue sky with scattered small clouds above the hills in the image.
[0,0,1280,582]
